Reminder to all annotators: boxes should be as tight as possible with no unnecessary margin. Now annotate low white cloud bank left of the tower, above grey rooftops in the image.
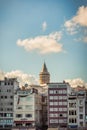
[0,70,38,86]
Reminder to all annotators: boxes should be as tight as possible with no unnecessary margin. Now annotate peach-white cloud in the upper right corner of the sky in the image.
[64,6,87,34]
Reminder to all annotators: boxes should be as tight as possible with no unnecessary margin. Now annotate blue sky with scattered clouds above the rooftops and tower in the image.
[0,0,87,87]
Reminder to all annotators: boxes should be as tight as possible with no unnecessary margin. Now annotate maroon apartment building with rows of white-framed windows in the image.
[48,82,71,130]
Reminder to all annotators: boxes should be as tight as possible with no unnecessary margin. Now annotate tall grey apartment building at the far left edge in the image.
[0,78,19,129]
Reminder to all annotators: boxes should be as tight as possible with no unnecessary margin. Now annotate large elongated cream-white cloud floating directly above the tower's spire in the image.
[17,32,63,54]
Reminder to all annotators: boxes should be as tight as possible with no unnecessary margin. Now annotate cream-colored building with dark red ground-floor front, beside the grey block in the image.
[14,88,42,127]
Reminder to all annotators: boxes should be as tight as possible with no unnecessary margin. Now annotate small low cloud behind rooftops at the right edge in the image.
[65,78,87,87]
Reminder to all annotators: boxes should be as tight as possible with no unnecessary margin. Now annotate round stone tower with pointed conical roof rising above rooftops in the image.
[39,62,50,84]
